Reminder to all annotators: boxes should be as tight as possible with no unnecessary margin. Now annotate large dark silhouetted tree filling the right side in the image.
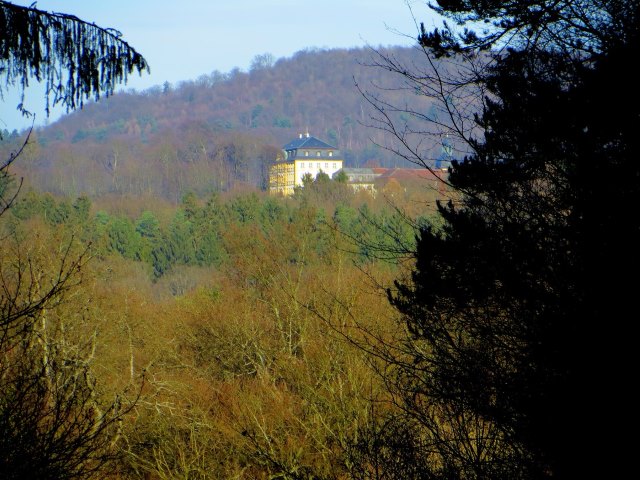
[361,1,640,479]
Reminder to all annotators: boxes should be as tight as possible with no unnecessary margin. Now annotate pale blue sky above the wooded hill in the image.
[0,0,440,130]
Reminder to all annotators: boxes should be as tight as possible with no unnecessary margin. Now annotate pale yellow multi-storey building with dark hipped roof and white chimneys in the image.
[269,132,344,195]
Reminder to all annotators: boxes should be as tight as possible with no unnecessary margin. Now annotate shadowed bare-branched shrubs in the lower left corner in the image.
[0,216,141,479]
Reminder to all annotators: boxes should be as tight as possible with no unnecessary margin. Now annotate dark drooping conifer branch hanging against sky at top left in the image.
[0,1,149,114]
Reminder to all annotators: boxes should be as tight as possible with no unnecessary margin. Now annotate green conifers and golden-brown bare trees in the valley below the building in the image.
[0,179,450,479]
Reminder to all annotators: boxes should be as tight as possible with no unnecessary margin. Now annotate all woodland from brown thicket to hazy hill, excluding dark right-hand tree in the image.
[0,8,450,479]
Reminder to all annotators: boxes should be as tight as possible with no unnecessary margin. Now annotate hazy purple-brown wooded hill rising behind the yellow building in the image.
[2,48,439,202]
